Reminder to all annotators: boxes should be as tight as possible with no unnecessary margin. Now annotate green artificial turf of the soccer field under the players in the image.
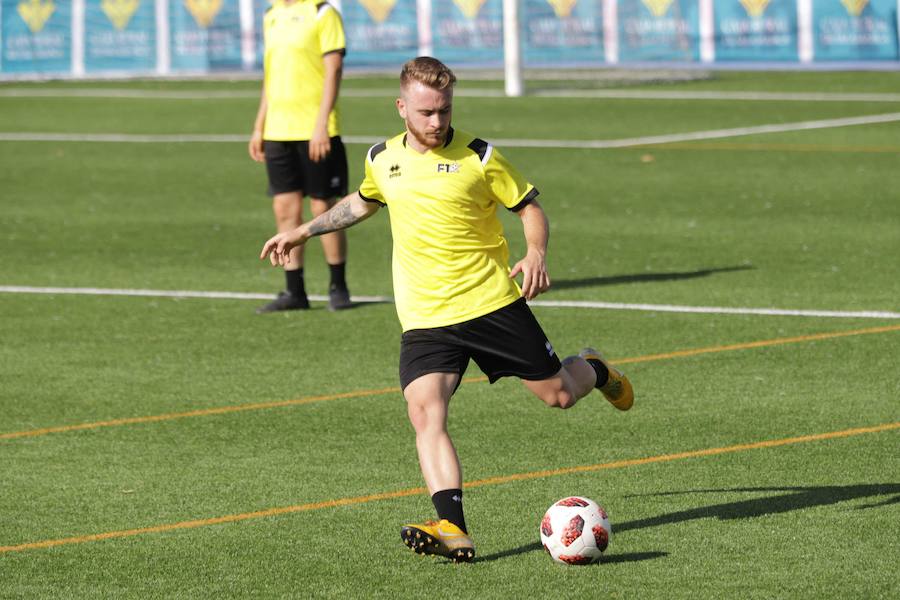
[0,72,900,599]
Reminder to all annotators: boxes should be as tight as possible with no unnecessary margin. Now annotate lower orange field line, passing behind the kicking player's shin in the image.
[0,422,900,554]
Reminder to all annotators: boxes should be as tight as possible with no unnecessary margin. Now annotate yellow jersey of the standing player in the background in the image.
[263,0,346,141]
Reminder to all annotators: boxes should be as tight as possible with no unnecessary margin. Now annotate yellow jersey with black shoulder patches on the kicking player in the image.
[359,129,538,331]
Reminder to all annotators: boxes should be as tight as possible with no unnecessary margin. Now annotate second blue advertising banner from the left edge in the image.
[84,0,156,72]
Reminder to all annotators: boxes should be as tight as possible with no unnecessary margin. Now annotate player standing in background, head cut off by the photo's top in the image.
[249,0,351,313]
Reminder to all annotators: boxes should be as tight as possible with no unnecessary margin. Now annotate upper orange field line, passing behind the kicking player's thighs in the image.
[0,325,900,440]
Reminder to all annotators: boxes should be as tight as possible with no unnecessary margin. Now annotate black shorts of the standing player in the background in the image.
[263,136,347,199]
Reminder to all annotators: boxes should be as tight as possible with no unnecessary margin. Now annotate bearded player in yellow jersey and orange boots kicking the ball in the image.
[260,57,634,562]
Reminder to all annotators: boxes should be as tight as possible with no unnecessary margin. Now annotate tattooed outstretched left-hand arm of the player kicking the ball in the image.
[259,192,381,265]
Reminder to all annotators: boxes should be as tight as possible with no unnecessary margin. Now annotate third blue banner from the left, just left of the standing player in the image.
[169,0,241,71]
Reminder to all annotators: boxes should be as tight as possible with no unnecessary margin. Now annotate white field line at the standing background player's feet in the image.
[0,285,900,319]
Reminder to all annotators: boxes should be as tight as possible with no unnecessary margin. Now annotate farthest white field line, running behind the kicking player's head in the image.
[0,88,900,102]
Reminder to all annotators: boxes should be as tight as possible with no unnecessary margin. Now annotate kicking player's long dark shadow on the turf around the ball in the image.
[475,483,900,564]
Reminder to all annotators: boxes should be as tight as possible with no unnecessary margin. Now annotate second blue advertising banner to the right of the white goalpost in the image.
[618,0,700,62]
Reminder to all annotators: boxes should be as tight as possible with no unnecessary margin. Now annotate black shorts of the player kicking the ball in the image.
[400,298,562,389]
